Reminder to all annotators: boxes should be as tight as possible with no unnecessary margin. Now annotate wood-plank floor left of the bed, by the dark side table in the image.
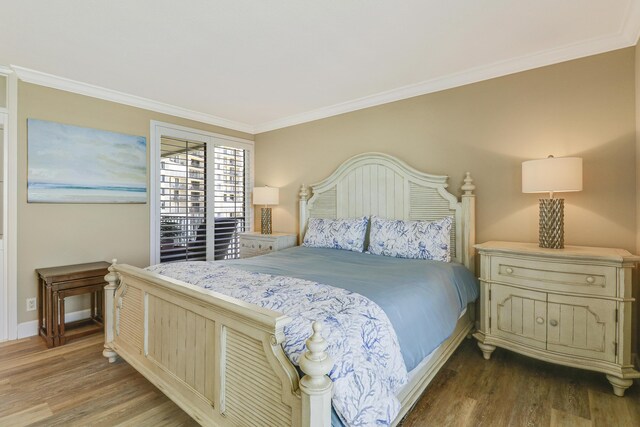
[0,334,198,427]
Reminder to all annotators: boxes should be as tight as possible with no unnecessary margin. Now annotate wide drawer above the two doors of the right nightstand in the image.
[491,256,616,296]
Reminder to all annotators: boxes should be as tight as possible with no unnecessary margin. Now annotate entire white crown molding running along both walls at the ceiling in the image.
[8,1,640,135]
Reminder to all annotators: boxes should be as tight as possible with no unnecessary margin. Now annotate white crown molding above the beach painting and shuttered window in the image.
[11,65,255,134]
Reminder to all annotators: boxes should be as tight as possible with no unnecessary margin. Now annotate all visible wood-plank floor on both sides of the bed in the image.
[0,335,640,427]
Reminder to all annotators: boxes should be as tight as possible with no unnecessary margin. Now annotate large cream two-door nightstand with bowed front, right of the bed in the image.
[474,242,640,396]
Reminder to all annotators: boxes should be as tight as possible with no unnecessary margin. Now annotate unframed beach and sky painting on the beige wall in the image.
[27,119,147,203]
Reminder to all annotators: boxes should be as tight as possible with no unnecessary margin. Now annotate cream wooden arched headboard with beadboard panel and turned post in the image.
[300,153,475,271]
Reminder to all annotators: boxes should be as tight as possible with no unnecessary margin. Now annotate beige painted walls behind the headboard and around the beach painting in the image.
[11,48,640,328]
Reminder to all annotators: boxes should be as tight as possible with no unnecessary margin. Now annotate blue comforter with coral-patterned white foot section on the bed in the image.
[149,247,478,426]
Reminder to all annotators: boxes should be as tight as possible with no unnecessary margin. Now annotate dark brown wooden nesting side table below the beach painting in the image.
[36,261,110,347]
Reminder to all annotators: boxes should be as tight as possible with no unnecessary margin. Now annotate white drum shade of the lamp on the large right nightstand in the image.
[522,157,582,193]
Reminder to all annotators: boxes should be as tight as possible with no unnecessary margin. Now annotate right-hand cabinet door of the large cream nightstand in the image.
[547,295,616,362]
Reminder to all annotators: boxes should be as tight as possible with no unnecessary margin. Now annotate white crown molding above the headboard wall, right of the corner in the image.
[254,27,640,134]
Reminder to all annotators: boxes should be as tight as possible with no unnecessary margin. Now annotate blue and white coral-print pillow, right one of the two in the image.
[369,216,453,262]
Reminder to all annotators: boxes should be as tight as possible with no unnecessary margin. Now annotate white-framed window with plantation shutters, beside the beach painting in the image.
[151,122,253,263]
